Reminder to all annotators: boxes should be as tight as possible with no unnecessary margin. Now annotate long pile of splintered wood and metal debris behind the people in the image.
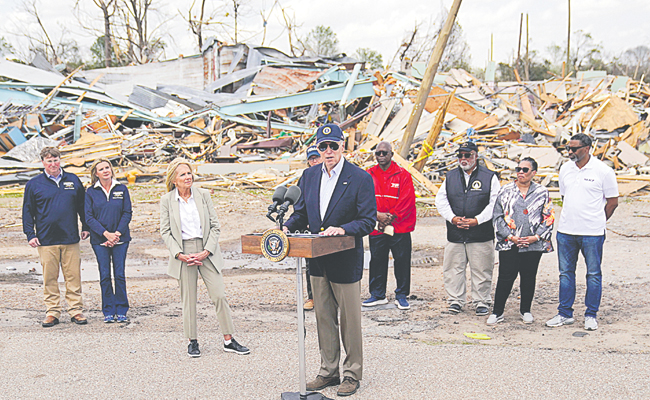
[0,44,650,198]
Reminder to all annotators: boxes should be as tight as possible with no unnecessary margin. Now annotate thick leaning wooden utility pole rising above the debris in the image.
[399,0,462,159]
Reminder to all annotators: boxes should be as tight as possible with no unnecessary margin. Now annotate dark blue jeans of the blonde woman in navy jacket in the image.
[92,243,129,317]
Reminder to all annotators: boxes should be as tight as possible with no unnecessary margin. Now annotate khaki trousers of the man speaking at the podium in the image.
[311,275,363,380]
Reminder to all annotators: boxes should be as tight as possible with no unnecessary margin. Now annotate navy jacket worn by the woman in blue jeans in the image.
[85,184,132,244]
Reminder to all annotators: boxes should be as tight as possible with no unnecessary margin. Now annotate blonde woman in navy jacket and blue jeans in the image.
[85,158,131,323]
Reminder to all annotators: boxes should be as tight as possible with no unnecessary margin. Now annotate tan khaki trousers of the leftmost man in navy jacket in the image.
[37,243,83,318]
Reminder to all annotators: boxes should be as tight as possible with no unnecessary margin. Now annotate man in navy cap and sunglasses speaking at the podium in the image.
[285,124,377,396]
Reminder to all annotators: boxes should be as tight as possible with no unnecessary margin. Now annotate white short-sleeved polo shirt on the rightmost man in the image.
[557,156,618,236]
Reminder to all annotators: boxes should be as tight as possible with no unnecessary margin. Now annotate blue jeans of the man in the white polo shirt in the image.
[557,232,605,318]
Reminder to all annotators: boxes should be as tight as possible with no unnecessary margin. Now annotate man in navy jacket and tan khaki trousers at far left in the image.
[23,147,90,328]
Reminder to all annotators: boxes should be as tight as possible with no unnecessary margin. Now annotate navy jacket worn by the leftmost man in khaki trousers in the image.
[23,170,88,246]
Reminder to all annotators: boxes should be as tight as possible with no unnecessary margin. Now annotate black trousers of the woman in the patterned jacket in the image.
[492,246,542,315]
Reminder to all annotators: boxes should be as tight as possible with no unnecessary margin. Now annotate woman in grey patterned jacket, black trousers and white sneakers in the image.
[487,157,555,325]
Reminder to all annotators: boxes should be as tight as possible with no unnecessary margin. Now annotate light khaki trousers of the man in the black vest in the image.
[443,240,494,307]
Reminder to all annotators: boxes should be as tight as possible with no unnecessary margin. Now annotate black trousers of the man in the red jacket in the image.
[369,232,411,299]
